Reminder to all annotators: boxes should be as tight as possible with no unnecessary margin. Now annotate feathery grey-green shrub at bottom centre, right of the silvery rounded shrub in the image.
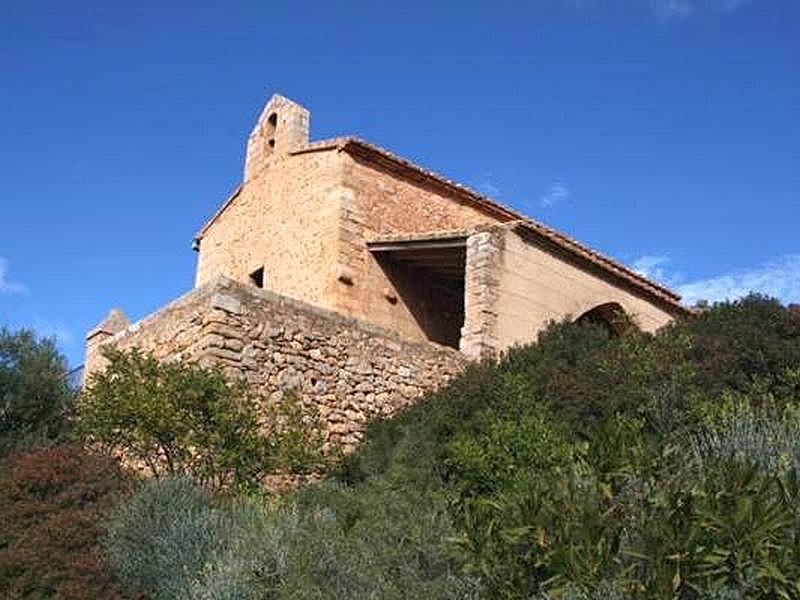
[281,480,480,600]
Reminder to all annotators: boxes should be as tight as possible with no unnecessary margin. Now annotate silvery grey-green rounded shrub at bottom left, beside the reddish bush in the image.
[106,478,288,599]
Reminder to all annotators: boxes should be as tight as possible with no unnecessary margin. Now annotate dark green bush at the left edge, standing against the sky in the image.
[0,327,73,454]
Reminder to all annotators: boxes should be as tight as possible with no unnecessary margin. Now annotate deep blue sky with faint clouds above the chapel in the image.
[0,0,800,364]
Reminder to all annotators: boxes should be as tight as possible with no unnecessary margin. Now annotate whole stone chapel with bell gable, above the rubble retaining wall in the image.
[196,96,685,357]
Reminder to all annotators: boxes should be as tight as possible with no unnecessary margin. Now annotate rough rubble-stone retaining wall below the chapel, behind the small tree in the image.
[87,277,466,447]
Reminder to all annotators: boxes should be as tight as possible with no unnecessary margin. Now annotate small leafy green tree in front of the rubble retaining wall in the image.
[78,349,322,488]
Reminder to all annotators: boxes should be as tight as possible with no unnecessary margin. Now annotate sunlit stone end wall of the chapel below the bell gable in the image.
[196,152,341,307]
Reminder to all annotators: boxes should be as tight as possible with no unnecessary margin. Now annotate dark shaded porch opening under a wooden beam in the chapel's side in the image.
[368,235,467,349]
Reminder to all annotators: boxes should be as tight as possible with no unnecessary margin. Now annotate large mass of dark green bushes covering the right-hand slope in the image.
[324,297,800,598]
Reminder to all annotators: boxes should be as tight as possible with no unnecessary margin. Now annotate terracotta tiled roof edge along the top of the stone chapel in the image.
[197,136,691,313]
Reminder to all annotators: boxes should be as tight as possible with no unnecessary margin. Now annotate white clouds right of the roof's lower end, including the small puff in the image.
[632,254,800,305]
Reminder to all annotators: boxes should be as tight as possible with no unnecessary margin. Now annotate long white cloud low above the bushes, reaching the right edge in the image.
[677,254,800,304]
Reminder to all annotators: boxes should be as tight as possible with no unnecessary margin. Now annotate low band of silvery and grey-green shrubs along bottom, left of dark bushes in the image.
[107,478,477,599]
